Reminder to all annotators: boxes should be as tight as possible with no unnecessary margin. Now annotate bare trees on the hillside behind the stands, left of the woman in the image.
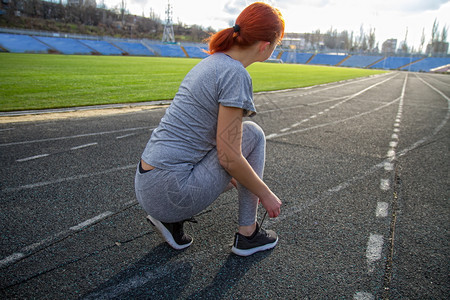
[0,0,214,42]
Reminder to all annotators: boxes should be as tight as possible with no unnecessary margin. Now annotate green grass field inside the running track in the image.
[0,53,384,111]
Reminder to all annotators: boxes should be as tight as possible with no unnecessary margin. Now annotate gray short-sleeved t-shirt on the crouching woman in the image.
[142,53,256,171]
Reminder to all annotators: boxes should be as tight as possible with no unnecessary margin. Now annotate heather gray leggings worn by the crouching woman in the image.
[135,121,266,226]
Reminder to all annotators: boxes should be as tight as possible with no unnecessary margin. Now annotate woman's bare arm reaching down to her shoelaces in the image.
[216,104,281,218]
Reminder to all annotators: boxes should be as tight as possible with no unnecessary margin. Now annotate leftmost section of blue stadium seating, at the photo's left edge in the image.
[0,33,52,53]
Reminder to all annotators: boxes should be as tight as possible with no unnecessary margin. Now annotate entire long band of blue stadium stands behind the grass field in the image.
[0,28,450,73]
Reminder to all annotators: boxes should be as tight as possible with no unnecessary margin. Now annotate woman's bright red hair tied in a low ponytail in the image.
[208,2,284,54]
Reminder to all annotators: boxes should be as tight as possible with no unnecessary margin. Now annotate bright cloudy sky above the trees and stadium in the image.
[103,0,450,49]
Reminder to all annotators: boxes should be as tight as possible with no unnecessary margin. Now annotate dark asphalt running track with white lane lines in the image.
[0,72,450,299]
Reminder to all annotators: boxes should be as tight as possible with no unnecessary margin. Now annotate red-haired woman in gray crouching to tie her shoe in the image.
[135,2,284,256]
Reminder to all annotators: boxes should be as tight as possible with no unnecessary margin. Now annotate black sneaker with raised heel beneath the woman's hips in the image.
[147,215,197,250]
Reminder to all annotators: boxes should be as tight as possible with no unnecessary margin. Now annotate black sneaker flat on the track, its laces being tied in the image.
[231,223,278,256]
